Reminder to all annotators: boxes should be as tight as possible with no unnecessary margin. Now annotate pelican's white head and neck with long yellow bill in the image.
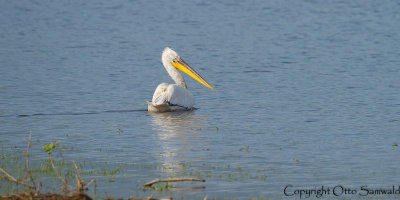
[161,47,214,90]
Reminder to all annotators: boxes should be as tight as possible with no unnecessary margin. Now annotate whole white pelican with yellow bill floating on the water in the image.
[147,47,214,112]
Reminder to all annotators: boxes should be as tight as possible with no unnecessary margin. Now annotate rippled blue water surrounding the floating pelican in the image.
[0,1,400,199]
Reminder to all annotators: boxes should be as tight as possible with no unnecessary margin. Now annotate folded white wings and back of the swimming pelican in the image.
[152,83,194,109]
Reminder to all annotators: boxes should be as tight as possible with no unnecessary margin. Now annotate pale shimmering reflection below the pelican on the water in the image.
[149,112,207,175]
